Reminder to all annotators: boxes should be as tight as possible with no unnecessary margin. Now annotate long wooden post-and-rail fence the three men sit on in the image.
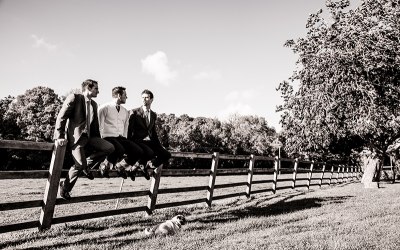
[0,140,361,233]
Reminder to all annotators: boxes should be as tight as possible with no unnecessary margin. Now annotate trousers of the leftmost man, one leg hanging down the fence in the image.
[64,134,114,192]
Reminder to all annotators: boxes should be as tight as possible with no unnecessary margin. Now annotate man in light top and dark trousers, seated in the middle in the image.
[98,86,143,180]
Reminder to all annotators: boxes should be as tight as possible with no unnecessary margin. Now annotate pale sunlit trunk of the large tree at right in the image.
[361,156,382,188]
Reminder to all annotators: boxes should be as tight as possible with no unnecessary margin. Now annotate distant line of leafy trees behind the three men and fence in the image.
[0,87,277,170]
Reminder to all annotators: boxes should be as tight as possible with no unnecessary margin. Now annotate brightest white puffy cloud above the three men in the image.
[141,51,178,85]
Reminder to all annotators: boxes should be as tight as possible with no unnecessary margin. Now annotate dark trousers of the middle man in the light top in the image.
[104,136,143,165]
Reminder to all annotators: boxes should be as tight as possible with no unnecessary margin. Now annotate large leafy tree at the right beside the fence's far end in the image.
[278,0,400,186]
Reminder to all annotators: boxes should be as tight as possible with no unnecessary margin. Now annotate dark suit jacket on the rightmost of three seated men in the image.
[128,107,161,145]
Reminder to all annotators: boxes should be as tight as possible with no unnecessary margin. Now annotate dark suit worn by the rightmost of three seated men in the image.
[128,107,171,167]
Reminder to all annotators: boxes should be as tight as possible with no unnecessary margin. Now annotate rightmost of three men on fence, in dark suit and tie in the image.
[128,89,171,179]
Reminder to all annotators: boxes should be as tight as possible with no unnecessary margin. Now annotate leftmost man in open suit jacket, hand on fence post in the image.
[54,79,114,200]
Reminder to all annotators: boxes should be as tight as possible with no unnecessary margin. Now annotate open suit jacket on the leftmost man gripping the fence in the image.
[54,94,100,146]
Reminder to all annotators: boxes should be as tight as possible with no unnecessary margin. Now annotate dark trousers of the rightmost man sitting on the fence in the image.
[136,141,171,167]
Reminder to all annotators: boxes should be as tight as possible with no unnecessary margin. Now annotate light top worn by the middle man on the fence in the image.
[99,102,129,138]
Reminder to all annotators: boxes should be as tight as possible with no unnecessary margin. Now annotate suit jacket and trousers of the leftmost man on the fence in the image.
[54,94,114,192]
